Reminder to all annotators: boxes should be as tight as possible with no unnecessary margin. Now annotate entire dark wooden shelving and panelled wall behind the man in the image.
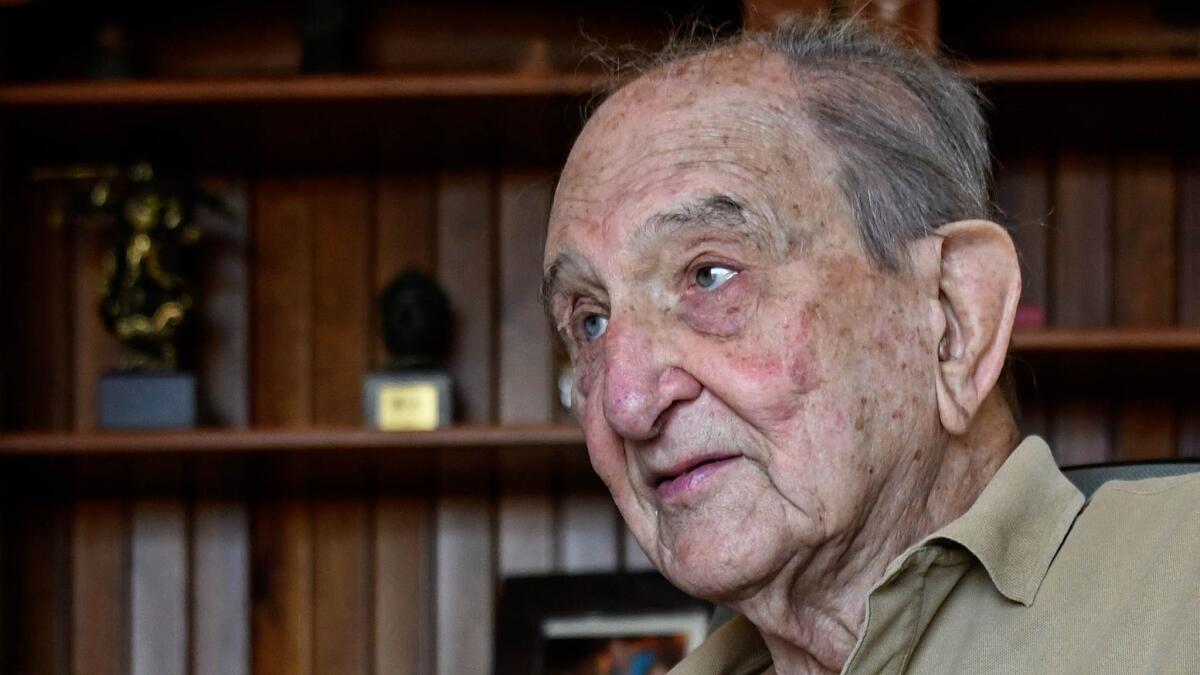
[0,0,1200,675]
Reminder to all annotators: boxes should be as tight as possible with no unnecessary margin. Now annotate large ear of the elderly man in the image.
[935,220,1021,436]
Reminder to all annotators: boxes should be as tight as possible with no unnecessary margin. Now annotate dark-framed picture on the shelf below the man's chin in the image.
[496,573,712,675]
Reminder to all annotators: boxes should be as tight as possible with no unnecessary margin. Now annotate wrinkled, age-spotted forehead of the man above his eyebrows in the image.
[546,47,836,261]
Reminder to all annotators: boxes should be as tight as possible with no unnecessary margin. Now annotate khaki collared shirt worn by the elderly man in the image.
[671,437,1200,675]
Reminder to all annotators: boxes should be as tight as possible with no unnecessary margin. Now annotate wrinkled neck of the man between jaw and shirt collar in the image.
[737,395,1019,675]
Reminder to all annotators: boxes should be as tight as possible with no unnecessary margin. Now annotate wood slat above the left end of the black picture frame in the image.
[497,172,554,575]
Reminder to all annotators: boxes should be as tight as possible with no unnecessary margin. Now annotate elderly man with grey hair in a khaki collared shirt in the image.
[544,15,1200,674]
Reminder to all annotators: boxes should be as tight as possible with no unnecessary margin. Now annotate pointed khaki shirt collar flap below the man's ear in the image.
[923,436,1085,607]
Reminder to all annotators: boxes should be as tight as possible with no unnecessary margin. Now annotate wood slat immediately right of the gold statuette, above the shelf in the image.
[197,177,250,428]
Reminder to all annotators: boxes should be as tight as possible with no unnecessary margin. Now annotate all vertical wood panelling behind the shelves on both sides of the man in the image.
[0,97,1200,675]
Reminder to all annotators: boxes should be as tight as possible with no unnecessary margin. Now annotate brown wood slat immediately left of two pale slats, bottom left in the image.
[71,500,130,675]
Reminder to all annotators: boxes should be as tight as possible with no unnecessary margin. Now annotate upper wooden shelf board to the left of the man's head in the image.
[0,73,604,108]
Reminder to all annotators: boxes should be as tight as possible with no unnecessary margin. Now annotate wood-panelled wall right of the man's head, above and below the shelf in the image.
[995,150,1200,465]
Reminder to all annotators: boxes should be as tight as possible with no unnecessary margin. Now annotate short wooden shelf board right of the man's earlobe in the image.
[1012,328,1200,353]
